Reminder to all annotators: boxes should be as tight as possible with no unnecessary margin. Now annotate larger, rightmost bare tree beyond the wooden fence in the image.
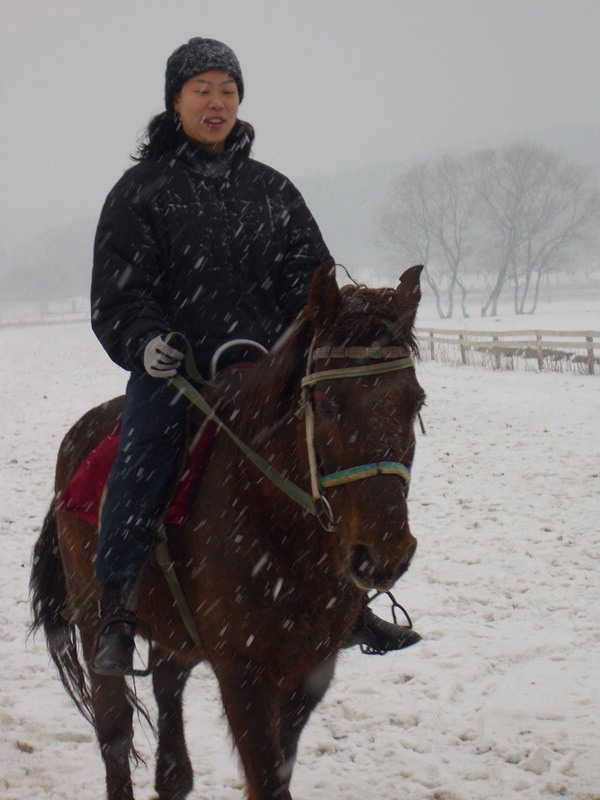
[470,142,600,316]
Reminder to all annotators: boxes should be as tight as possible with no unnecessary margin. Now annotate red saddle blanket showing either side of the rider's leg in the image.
[60,422,217,526]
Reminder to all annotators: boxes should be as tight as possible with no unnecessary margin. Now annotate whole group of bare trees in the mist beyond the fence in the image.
[378,142,600,318]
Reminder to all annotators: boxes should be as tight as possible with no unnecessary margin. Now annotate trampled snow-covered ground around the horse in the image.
[0,315,600,800]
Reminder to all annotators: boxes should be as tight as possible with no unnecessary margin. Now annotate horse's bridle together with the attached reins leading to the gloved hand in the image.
[170,337,414,531]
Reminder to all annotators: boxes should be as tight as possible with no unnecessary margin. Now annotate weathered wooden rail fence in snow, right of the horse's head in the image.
[416,328,600,375]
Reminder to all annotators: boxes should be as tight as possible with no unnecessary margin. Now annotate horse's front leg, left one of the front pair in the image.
[214,661,292,800]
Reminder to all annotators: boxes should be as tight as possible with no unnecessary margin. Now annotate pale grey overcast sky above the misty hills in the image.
[0,0,600,248]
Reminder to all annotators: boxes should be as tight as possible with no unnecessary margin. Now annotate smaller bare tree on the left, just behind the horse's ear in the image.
[379,156,475,319]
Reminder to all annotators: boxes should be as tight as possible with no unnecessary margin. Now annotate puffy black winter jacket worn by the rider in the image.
[92,122,329,371]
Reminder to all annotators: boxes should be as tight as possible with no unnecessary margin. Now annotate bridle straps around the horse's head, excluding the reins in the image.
[300,339,414,531]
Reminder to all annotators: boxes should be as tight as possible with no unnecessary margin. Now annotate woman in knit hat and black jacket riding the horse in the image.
[92,37,418,674]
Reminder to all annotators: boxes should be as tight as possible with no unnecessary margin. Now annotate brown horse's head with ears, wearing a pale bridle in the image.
[304,262,425,591]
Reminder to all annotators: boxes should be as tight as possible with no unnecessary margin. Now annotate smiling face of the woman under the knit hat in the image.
[173,70,240,153]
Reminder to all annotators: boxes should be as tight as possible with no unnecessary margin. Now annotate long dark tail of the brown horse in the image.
[29,500,94,725]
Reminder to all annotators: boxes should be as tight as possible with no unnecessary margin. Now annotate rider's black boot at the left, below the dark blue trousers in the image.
[92,587,136,676]
